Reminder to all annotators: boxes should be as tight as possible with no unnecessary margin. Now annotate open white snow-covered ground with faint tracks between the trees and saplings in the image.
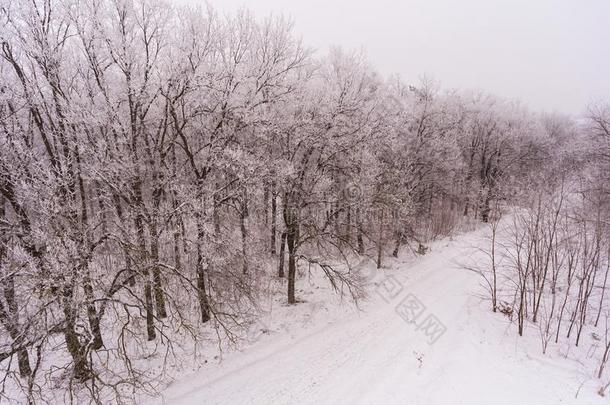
[159,226,609,405]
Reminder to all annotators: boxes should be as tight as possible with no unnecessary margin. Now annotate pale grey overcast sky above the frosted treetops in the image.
[173,0,610,115]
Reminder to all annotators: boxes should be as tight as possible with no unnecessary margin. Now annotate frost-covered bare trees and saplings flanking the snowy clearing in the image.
[0,0,610,404]
